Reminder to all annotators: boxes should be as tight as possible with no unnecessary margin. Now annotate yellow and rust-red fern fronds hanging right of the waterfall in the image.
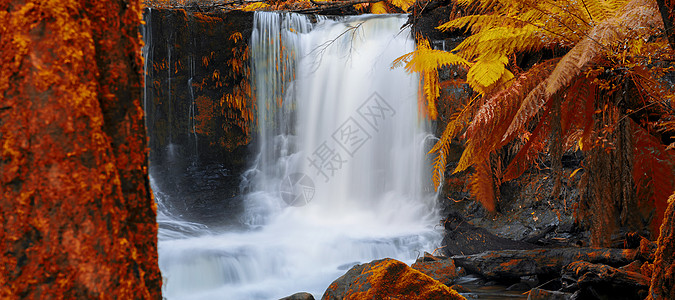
[394,0,675,245]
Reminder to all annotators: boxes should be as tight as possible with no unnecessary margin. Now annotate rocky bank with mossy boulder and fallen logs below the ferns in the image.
[283,239,655,300]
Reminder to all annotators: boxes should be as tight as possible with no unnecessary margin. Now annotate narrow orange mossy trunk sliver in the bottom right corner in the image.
[647,194,675,300]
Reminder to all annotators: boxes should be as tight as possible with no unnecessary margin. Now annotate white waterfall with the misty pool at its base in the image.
[158,12,440,299]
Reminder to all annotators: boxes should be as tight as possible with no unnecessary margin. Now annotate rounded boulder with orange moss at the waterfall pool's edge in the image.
[321,258,465,300]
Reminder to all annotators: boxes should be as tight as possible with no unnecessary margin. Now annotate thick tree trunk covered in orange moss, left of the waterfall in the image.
[0,0,161,299]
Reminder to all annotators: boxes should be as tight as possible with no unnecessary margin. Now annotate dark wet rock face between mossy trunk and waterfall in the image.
[144,9,255,225]
